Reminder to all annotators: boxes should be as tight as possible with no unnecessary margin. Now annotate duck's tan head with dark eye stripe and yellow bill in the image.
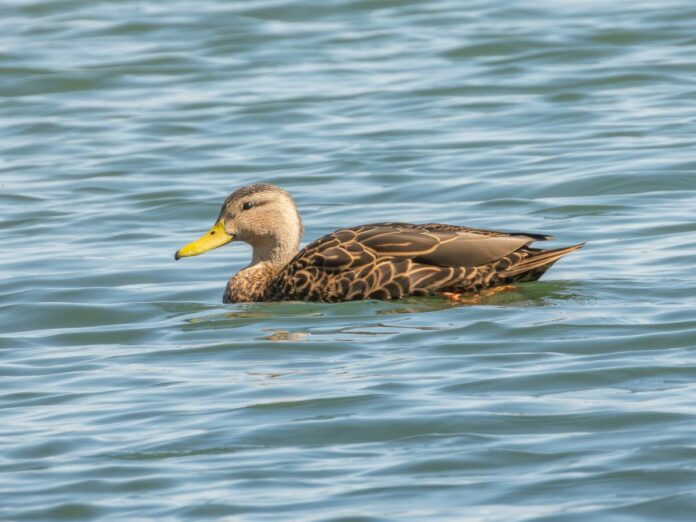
[174,183,302,264]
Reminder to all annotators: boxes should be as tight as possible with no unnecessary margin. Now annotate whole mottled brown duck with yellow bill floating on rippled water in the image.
[174,183,585,303]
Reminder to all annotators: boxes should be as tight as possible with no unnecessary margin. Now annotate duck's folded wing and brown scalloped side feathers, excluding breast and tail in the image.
[268,223,534,301]
